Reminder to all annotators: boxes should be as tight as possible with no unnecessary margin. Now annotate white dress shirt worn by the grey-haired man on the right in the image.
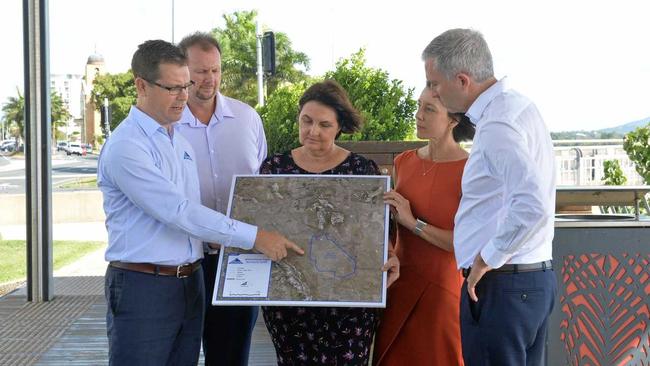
[454,79,555,268]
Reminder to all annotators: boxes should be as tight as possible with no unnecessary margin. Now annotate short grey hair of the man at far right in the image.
[422,28,494,82]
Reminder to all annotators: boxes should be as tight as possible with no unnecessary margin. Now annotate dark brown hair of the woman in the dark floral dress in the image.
[298,79,363,137]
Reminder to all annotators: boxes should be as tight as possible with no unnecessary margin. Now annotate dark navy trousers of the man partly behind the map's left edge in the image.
[202,254,259,366]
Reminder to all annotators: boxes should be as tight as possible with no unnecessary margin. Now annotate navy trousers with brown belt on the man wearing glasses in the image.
[104,266,205,366]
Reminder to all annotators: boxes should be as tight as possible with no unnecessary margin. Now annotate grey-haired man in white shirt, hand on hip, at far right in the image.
[422,29,557,366]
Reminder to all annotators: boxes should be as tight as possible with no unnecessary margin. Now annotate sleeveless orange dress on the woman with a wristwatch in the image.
[373,150,467,366]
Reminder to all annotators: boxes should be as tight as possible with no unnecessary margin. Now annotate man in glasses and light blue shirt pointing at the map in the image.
[97,40,302,365]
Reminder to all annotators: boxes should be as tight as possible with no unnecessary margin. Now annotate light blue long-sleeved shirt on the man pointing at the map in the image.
[97,107,257,265]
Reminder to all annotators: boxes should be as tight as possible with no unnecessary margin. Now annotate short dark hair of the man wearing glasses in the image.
[131,39,187,81]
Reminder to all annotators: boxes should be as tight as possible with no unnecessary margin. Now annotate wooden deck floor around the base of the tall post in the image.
[0,276,276,366]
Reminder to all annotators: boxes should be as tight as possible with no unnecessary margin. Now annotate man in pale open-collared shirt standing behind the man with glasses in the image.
[176,32,267,365]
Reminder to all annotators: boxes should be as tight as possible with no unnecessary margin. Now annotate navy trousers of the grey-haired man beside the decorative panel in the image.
[460,269,557,366]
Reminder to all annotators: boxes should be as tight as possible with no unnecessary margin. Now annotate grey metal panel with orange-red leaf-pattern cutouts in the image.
[549,228,650,366]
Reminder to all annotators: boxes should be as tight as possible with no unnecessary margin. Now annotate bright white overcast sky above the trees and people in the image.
[0,0,650,131]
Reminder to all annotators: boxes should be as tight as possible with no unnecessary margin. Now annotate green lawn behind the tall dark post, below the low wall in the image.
[0,240,106,284]
